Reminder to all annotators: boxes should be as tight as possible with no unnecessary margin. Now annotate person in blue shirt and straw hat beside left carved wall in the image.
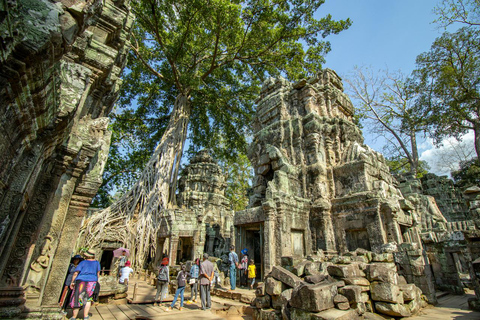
[70,249,100,320]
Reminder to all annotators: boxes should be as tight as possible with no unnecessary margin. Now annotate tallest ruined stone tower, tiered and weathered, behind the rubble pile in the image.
[235,69,430,284]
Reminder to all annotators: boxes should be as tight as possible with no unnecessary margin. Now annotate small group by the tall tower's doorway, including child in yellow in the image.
[228,246,257,291]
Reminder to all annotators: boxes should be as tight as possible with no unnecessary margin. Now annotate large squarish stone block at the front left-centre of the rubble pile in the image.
[290,283,337,312]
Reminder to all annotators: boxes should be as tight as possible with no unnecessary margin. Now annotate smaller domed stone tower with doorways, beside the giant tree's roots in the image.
[156,151,234,265]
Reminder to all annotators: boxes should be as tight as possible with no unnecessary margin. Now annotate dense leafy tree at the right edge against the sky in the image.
[413,27,480,162]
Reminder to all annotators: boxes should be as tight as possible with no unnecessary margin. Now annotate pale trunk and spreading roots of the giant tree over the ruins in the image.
[85,94,191,268]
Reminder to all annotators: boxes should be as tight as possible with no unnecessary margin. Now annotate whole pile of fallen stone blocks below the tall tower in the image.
[254,249,427,320]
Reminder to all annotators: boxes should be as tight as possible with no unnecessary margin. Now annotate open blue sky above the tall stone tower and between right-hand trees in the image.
[317,0,473,174]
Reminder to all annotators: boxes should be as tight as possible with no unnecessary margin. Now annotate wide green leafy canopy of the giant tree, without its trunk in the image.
[95,0,351,202]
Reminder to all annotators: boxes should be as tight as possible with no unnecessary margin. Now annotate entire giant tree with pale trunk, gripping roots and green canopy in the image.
[87,0,350,264]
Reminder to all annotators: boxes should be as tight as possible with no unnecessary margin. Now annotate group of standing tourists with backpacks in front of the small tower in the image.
[154,253,215,311]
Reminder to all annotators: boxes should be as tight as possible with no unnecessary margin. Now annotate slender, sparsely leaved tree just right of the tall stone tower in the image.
[346,67,423,176]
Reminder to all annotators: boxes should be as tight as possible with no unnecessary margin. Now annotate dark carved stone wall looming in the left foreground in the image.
[0,0,133,319]
